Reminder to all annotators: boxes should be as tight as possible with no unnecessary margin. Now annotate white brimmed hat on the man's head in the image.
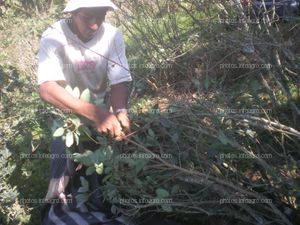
[63,0,118,13]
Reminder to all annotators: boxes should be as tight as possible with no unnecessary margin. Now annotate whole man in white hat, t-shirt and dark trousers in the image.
[38,0,132,225]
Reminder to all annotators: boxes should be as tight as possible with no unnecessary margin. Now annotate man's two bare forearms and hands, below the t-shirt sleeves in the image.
[40,81,130,140]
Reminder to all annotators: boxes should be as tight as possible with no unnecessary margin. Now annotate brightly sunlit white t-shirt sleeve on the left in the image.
[38,38,66,85]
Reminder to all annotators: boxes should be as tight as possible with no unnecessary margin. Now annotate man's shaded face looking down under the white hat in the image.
[72,8,107,42]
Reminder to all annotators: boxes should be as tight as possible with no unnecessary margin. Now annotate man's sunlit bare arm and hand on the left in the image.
[39,81,121,137]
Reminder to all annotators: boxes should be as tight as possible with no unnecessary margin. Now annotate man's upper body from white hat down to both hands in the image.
[38,0,131,137]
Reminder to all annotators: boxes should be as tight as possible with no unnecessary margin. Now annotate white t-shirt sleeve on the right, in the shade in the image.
[107,31,132,85]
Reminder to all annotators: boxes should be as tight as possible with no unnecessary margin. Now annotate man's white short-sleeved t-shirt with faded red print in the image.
[38,19,132,97]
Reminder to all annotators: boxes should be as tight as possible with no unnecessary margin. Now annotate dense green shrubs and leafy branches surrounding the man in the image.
[0,0,300,225]
